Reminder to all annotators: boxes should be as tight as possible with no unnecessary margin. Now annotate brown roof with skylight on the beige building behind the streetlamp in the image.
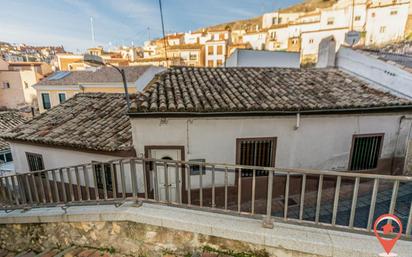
[37,65,150,85]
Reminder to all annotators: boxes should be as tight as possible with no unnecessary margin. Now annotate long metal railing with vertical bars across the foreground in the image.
[0,158,412,238]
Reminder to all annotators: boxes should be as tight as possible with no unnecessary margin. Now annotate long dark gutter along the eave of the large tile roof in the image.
[126,105,412,118]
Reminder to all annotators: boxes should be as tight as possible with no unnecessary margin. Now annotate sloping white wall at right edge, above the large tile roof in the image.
[336,47,412,97]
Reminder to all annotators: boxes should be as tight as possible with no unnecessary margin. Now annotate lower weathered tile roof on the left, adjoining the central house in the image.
[2,93,133,152]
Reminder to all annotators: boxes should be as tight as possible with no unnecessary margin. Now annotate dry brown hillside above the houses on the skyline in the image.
[198,0,337,31]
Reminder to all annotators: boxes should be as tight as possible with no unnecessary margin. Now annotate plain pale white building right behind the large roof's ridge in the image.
[225,49,300,68]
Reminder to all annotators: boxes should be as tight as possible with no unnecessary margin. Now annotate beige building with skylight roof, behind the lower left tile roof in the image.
[34,65,163,112]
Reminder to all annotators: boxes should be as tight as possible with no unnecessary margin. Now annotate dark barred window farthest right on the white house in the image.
[349,134,383,170]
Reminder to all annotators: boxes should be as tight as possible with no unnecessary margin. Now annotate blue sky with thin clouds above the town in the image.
[0,0,300,52]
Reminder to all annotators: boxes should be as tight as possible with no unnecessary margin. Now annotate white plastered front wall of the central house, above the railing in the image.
[131,114,410,185]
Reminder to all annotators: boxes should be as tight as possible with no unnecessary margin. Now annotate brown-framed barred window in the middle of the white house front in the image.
[236,138,276,177]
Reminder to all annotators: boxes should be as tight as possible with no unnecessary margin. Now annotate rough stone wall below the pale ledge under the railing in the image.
[0,221,317,257]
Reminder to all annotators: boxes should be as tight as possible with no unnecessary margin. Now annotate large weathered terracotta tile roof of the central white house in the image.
[131,67,412,114]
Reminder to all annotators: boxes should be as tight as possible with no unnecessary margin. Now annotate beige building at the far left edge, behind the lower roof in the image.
[0,60,52,109]
